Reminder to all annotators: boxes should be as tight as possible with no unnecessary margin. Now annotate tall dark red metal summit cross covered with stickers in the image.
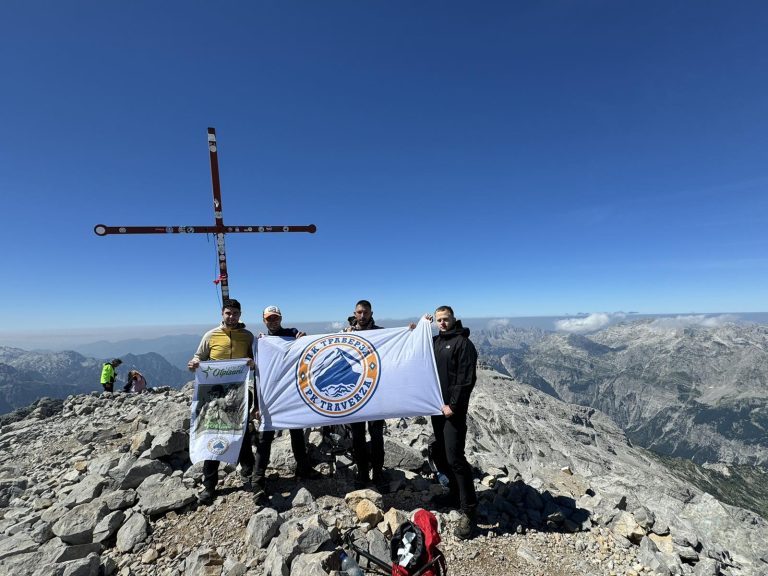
[93,128,317,301]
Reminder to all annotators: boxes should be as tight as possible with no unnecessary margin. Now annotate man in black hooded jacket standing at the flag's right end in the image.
[427,306,477,540]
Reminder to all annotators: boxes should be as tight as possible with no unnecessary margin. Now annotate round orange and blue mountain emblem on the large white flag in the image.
[296,335,380,418]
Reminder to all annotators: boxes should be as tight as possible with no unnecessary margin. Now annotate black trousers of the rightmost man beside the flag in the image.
[432,412,477,512]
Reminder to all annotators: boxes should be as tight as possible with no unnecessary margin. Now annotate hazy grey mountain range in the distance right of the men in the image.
[481,320,768,466]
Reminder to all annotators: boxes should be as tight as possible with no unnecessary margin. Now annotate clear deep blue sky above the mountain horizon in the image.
[0,0,768,330]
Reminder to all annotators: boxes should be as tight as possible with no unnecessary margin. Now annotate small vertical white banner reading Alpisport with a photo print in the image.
[189,359,251,464]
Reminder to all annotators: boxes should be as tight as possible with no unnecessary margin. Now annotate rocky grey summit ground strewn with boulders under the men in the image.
[0,370,768,576]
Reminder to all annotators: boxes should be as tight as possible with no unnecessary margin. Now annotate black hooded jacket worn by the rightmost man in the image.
[432,320,477,412]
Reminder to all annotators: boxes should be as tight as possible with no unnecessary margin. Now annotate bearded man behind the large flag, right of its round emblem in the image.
[345,300,388,492]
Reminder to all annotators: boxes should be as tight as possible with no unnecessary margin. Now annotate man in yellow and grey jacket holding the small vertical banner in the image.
[187,300,256,504]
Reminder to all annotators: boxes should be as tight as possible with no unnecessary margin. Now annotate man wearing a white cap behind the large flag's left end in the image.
[253,306,317,504]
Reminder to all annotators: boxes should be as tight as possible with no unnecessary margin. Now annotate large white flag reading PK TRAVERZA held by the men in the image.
[256,319,443,430]
